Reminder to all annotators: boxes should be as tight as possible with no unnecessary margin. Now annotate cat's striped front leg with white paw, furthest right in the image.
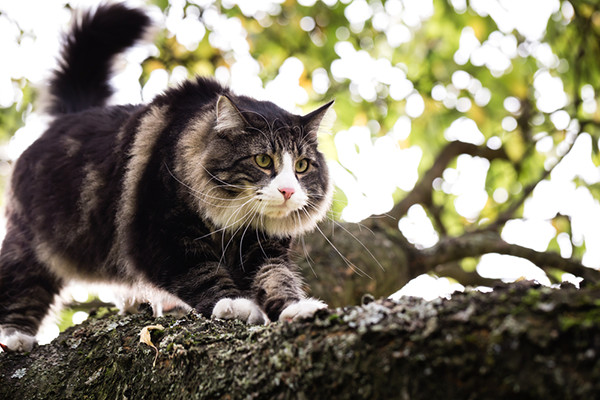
[254,262,327,321]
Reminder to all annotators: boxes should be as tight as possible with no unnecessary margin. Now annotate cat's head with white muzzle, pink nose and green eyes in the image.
[178,96,333,237]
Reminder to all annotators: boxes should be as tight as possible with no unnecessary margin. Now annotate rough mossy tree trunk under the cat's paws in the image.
[0,283,600,399]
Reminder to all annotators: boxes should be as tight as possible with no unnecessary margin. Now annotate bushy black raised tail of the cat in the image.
[46,4,151,115]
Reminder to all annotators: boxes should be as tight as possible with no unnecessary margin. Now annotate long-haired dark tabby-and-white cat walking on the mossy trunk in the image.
[0,4,332,350]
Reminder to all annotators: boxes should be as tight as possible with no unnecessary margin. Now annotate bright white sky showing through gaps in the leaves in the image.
[0,0,600,342]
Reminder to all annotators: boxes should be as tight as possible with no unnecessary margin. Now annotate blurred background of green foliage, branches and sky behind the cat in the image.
[0,0,600,341]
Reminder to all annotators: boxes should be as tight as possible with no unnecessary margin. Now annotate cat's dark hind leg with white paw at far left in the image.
[0,231,62,351]
